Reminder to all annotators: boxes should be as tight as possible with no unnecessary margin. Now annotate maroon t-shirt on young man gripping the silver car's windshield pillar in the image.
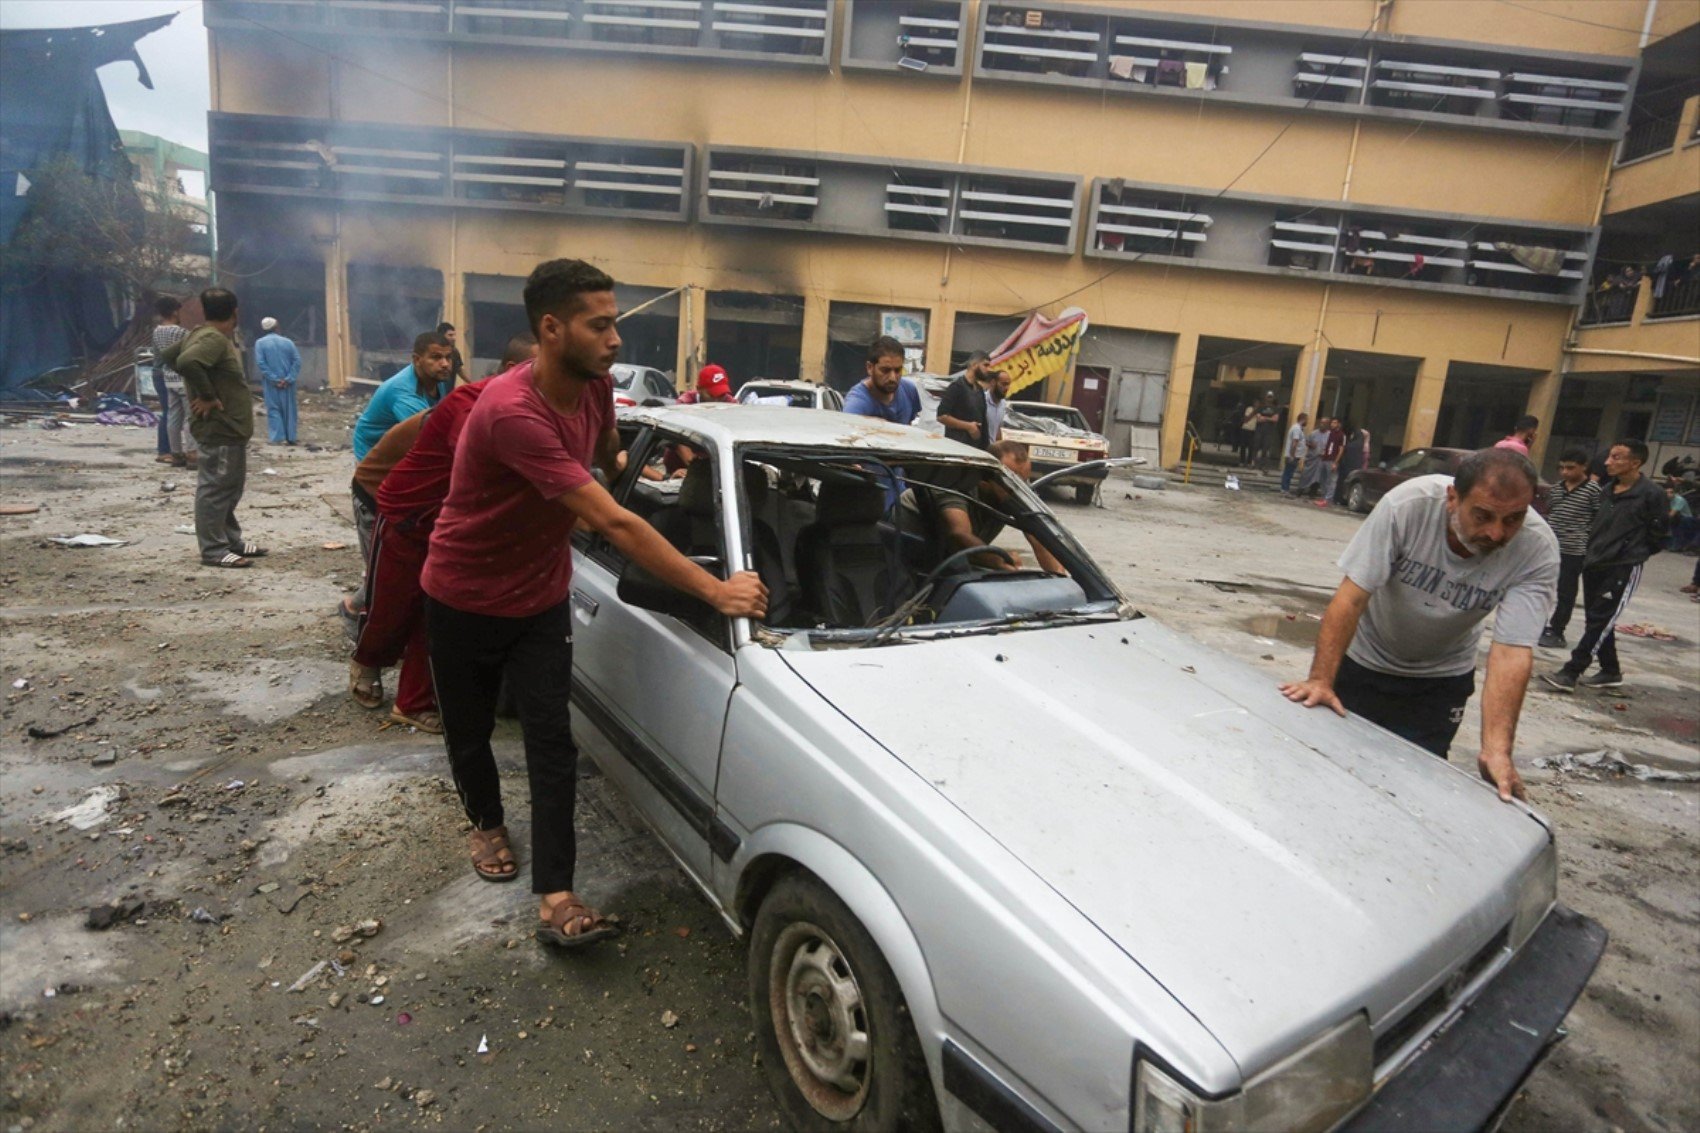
[420,362,614,618]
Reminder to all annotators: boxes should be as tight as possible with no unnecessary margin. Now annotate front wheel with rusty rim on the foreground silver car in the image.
[750,873,940,1133]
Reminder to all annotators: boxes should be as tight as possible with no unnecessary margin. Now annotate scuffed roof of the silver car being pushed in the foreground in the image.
[621,401,998,464]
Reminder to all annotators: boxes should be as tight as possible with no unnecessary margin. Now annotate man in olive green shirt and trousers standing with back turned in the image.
[162,288,265,567]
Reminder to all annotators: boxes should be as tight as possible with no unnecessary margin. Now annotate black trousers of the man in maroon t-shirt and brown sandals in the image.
[425,597,578,893]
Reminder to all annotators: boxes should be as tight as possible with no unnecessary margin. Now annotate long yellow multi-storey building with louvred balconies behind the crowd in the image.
[206,0,1700,463]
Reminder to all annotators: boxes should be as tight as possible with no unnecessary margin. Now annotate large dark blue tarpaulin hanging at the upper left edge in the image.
[0,14,175,392]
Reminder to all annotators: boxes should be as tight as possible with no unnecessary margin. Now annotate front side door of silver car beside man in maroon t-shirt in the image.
[571,430,736,883]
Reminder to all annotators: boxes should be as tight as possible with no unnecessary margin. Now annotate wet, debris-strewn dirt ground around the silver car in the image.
[0,395,1700,1133]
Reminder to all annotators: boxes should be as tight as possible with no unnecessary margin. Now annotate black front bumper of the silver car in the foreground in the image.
[1336,905,1607,1133]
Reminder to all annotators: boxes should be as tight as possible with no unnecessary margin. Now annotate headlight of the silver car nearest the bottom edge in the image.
[1134,1014,1375,1133]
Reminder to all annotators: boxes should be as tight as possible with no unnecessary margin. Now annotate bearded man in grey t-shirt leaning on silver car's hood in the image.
[1280,449,1559,801]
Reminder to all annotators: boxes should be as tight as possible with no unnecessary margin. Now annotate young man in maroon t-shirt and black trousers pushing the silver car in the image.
[422,260,767,946]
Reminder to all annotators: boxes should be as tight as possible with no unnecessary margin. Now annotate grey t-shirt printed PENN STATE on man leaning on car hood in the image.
[1340,476,1559,677]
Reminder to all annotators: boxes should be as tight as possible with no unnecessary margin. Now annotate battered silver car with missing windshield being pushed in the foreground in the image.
[571,405,1605,1133]
